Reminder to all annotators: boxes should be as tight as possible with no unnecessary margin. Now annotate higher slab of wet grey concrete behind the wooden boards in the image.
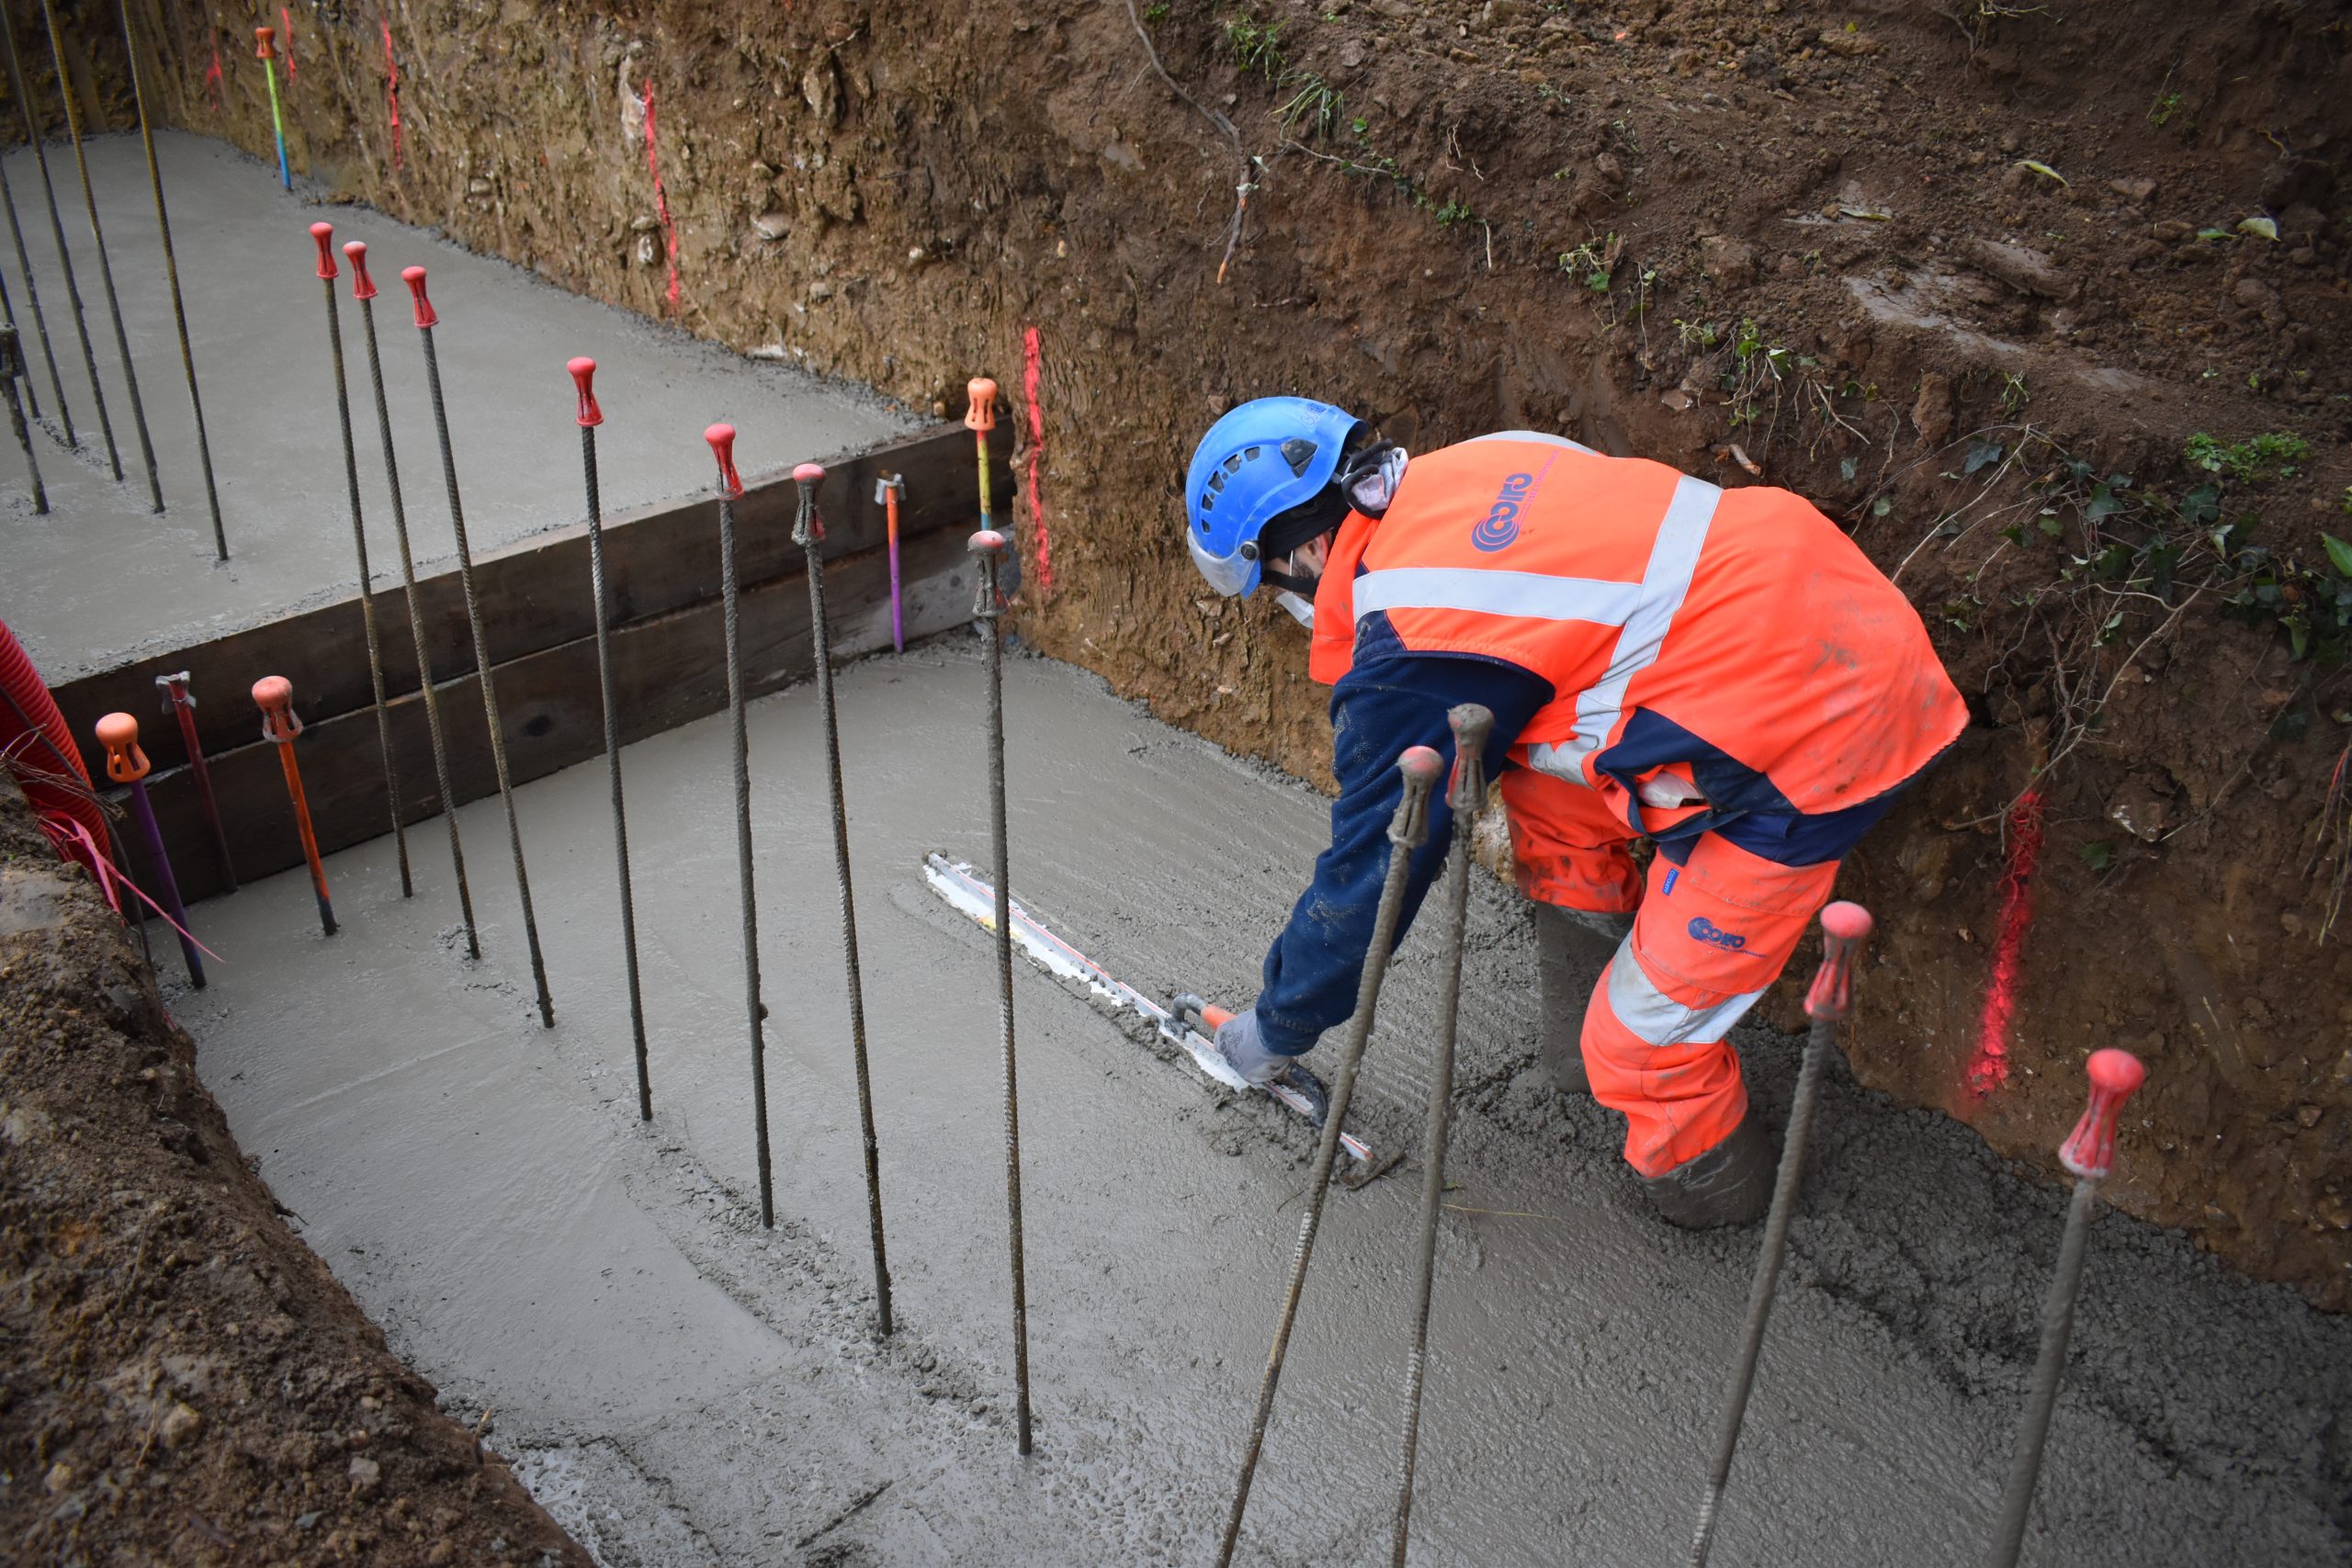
[0,134,915,684]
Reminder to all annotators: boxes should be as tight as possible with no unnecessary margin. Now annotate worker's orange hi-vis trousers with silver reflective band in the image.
[1503,769,1837,1176]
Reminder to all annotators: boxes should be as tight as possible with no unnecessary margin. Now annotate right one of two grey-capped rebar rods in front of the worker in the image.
[1387,703,1494,1568]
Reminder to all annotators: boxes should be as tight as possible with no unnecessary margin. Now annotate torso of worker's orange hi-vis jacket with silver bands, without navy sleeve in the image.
[1307,430,1969,841]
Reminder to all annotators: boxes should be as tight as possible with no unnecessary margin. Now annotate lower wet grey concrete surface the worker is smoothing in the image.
[172,635,2352,1568]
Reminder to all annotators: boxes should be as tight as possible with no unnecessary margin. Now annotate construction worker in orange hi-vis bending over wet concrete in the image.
[1185,398,1969,1227]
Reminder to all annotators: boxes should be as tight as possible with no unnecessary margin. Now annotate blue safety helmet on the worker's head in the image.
[1183,398,1357,597]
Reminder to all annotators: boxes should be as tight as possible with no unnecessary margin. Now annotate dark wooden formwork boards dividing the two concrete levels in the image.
[56,425,1013,900]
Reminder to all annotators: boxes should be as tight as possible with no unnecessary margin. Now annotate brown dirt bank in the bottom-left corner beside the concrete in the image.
[0,771,588,1568]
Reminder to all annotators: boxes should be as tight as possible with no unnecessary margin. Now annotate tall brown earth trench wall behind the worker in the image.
[18,0,2352,1307]
